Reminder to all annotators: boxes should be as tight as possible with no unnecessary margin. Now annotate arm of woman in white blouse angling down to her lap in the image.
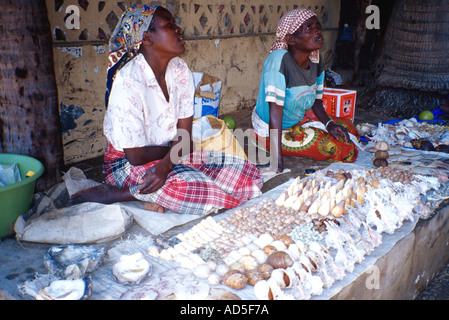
[130,117,193,194]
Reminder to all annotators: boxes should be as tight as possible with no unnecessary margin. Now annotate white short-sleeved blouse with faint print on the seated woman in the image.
[104,54,195,151]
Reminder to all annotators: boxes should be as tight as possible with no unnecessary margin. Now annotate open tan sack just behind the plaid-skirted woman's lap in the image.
[193,115,247,159]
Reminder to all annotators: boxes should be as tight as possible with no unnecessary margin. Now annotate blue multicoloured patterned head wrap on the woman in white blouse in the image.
[106,4,159,107]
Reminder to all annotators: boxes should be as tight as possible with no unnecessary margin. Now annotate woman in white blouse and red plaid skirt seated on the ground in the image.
[72,5,262,215]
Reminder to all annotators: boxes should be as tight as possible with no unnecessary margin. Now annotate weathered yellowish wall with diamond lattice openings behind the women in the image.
[47,0,340,164]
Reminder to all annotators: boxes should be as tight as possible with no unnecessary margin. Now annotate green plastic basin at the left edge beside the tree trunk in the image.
[0,153,44,238]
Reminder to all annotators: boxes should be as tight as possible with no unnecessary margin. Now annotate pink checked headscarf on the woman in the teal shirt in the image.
[270,9,320,63]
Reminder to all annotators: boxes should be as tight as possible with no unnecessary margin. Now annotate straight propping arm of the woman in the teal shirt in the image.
[269,102,284,173]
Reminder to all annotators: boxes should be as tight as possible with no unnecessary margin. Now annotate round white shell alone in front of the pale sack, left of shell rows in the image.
[112,252,151,285]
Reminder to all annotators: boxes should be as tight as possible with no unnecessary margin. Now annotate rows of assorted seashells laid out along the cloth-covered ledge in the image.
[148,167,440,299]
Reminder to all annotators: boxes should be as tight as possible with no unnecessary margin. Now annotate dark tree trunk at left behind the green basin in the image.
[0,0,63,190]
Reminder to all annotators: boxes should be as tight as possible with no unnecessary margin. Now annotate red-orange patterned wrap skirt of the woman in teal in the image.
[256,110,360,162]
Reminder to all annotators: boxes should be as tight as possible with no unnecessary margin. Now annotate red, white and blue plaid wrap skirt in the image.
[104,143,262,215]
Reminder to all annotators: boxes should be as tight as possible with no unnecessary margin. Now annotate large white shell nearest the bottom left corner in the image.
[36,277,91,300]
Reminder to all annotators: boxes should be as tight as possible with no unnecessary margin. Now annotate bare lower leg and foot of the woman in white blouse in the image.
[70,184,135,205]
